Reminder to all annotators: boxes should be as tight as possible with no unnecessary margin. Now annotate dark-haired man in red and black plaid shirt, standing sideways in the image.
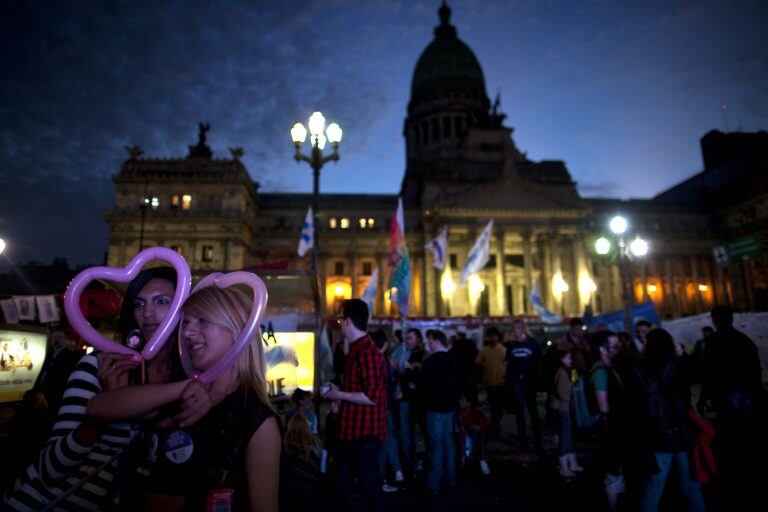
[325,299,387,511]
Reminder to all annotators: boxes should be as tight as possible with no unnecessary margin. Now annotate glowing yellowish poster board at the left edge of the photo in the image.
[0,324,48,403]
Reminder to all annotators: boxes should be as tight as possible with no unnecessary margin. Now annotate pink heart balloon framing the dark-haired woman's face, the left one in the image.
[64,247,192,361]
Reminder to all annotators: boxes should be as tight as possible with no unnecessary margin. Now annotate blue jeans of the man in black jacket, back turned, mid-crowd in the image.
[427,412,456,491]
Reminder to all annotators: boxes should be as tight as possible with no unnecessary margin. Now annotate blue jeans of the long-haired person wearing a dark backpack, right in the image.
[640,452,704,512]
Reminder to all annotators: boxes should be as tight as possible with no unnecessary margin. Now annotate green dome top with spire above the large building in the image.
[411,2,487,102]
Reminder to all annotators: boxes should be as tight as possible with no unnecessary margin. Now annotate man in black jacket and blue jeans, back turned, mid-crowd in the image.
[420,330,459,493]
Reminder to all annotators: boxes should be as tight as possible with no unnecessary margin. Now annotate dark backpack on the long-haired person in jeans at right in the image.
[631,363,696,453]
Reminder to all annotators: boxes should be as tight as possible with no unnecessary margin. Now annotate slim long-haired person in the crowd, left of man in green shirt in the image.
[548,350,583,478]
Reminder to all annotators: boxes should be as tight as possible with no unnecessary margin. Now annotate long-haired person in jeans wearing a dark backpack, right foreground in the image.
[625,328,704,512]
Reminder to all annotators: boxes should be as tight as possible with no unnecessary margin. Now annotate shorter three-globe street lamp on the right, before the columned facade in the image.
[595,215,648,332]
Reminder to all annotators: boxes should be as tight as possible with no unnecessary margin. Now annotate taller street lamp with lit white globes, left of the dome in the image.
[291,112,342,273]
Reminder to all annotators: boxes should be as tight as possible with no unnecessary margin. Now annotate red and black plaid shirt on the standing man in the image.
[338,335,387,441]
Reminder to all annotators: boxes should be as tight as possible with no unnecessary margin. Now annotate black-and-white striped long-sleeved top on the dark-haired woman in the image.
[3,354,135,511]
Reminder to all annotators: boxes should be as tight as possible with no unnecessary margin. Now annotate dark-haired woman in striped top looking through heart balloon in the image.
[4,267,194,510]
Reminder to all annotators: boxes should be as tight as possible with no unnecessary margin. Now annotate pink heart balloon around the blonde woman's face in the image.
[179,270,268,384]
